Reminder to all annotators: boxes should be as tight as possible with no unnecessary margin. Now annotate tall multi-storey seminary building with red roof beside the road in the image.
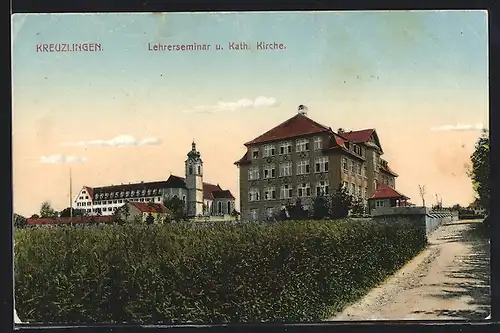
[235,105,398,220]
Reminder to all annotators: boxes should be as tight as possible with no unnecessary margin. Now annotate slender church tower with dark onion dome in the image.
[185,141,203,217]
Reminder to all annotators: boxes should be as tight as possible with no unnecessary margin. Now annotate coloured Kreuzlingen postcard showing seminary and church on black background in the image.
[12,11,491,325]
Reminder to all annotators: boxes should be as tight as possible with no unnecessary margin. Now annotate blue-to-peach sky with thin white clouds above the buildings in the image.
[12,11,489,216]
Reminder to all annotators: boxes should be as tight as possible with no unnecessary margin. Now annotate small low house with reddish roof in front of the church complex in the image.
[116,201,171,222]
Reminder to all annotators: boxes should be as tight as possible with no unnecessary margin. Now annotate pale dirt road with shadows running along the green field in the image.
[330,220,490,320]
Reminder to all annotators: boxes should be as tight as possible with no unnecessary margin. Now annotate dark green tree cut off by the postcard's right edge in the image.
[467,131,490,213]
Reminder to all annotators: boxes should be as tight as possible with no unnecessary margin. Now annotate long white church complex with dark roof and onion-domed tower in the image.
[72,142,235,217]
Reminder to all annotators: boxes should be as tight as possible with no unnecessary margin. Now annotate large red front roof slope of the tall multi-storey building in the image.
[245,113,331,146]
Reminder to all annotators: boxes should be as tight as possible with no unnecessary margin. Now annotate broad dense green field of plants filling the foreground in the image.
[15,221,426,324]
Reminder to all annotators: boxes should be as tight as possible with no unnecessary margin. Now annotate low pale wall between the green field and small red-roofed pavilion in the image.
[372,207,458,235]
